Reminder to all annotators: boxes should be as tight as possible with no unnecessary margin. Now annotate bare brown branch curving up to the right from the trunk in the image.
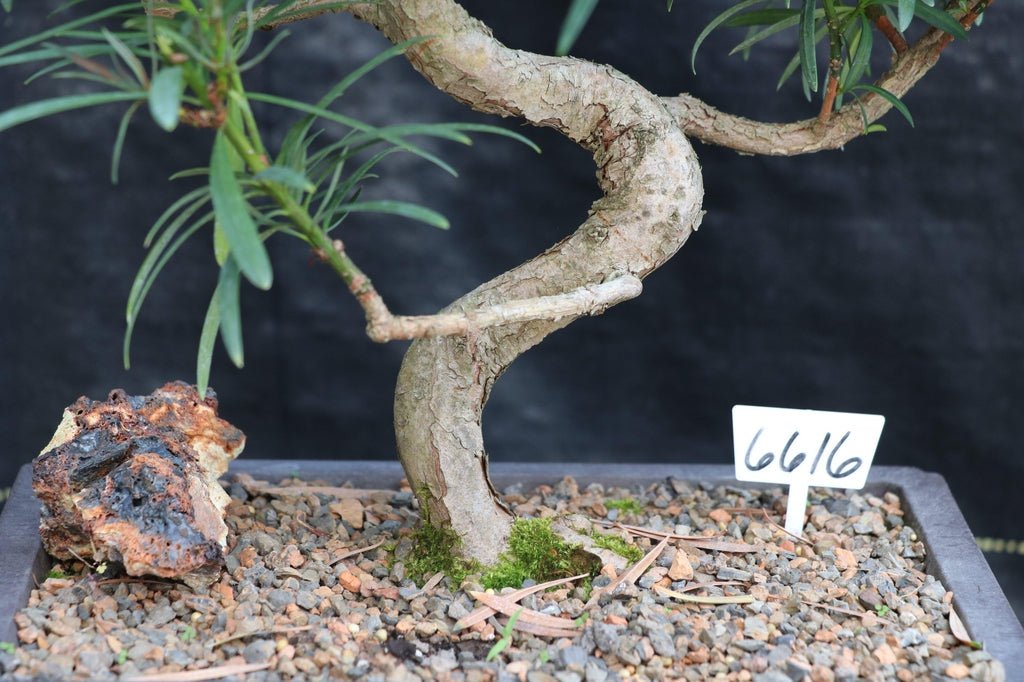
[664,0,989,157]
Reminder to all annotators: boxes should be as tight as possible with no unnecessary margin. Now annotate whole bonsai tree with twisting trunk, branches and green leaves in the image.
[0,0,987,564]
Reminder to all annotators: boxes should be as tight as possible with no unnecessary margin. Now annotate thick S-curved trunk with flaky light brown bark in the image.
[350,0,703,564]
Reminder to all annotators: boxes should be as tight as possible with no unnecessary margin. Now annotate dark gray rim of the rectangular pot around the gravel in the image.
[0,460,1024,672]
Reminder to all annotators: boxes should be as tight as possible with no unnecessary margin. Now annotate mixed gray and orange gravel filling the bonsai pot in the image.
[0,477,1006,682]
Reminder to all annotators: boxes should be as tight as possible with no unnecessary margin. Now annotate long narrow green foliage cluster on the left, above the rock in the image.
[0,0,536,394]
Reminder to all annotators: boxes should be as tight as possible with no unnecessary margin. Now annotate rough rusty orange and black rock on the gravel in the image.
[33,382,245,584]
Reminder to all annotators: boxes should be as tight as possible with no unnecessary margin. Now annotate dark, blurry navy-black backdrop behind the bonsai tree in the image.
[0,0,1024,612]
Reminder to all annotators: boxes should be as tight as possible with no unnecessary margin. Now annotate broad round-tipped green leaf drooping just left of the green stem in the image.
[210,132,273,288]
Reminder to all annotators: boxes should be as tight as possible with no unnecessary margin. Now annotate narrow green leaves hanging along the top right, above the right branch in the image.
[557,0,983,124]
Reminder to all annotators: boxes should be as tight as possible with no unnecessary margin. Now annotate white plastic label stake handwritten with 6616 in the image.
[732,404,886,537]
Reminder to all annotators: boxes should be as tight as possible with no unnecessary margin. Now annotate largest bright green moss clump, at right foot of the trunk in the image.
[482,518,599,590]
